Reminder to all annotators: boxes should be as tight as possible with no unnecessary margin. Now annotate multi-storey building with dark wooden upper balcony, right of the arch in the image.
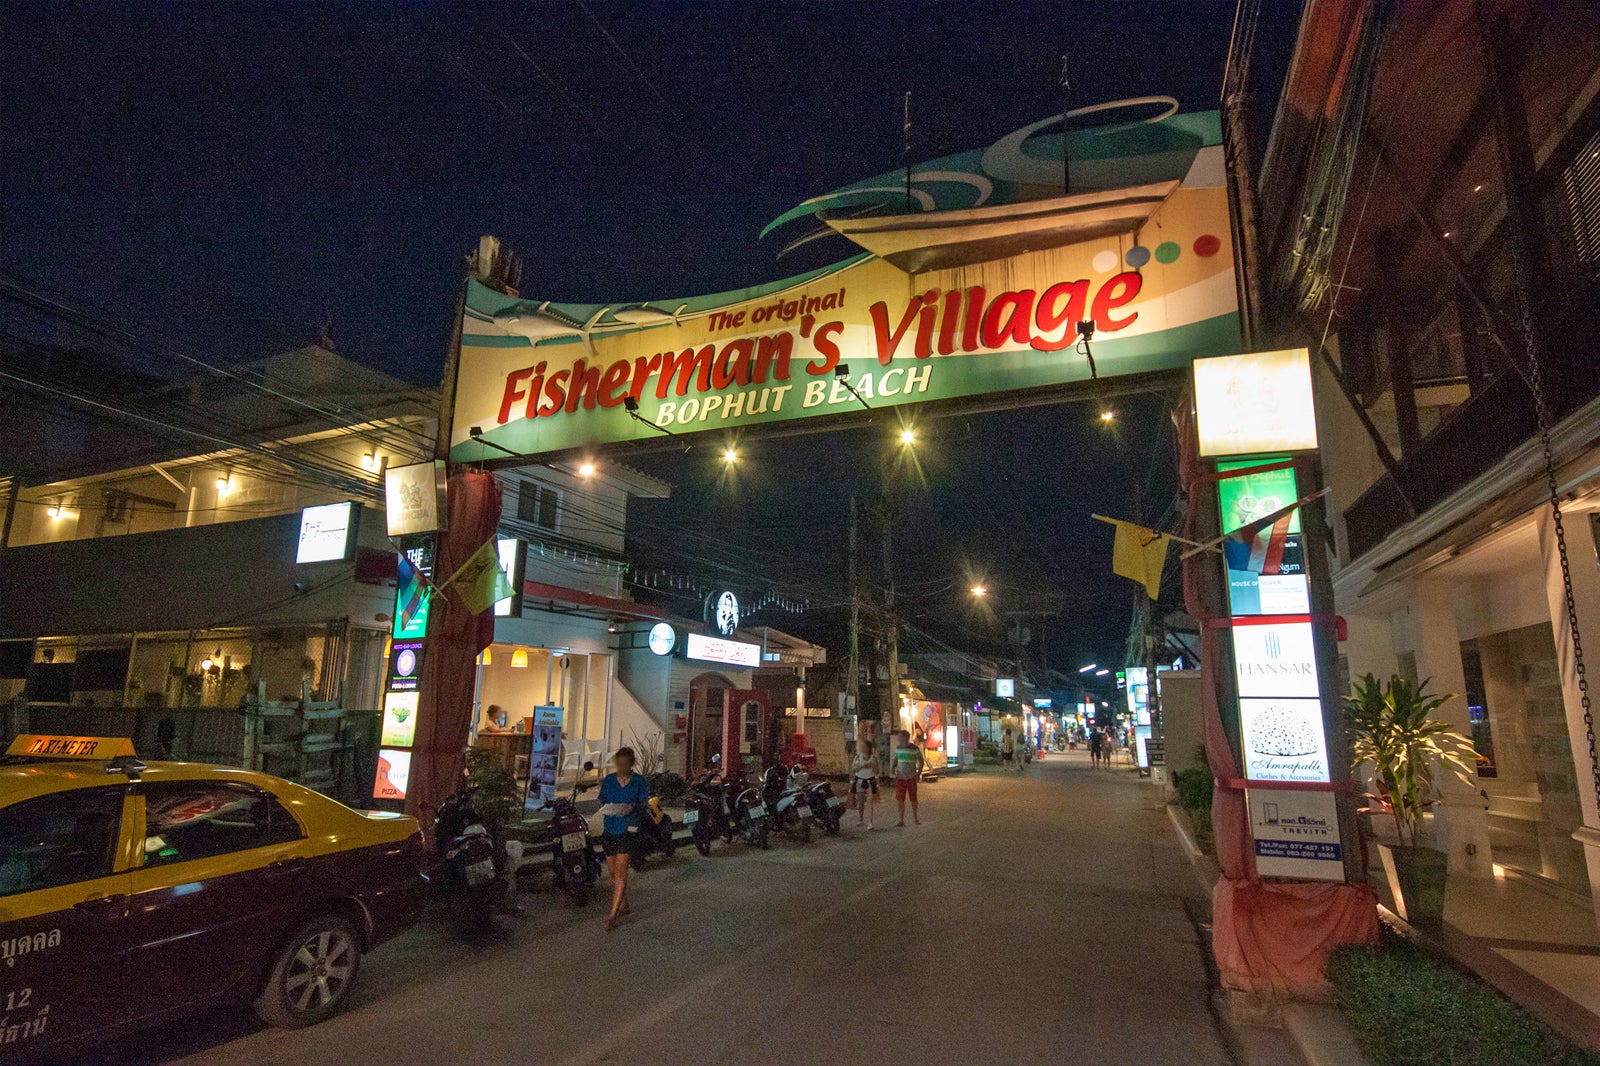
[1240,0,1600,979]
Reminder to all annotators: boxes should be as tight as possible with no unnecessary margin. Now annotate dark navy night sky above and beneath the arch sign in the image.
[0,0,1293,688]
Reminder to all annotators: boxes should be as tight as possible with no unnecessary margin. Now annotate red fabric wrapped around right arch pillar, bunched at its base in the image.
[1173,397,1378,996]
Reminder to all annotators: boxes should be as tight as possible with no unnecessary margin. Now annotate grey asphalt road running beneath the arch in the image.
[104,754,1256,1066]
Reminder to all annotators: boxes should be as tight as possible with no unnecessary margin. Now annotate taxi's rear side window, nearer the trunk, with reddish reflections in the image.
[142,781,304,866]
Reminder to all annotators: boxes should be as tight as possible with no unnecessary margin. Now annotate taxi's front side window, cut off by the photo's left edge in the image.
[0,787,126,896]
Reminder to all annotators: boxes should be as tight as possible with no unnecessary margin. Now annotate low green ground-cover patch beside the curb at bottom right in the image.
[1328,938,1600,1066]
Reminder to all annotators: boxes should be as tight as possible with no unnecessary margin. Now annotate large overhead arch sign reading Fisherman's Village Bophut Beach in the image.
[450,99,1240,464]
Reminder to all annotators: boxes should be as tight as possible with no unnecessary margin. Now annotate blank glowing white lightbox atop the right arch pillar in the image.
[1194,347,1317,451]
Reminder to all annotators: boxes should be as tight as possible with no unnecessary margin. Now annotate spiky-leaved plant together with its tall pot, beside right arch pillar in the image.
[1344,674,1477,928]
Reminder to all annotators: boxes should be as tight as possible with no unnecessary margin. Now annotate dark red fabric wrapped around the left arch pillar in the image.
[405,472,501,832]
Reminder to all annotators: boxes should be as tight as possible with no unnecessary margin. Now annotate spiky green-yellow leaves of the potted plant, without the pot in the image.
[1344,674,1478,848]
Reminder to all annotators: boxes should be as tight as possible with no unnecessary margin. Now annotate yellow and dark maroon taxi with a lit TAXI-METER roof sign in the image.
[0,736,426,1060]
